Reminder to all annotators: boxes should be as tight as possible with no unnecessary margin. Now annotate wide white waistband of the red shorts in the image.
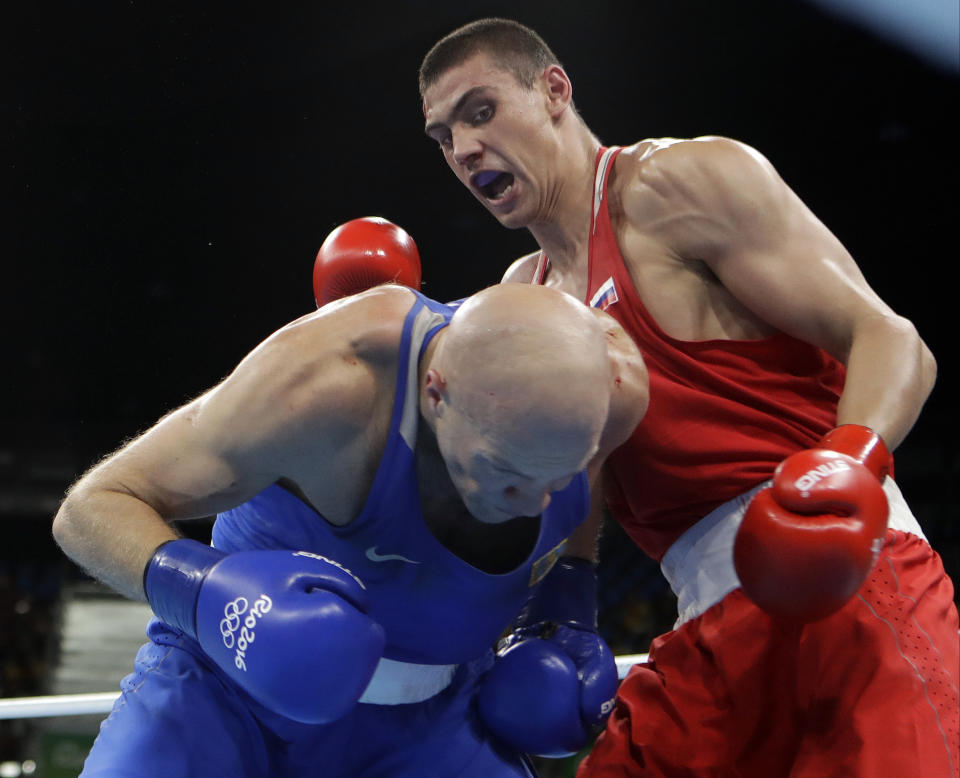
[660,478,926,629]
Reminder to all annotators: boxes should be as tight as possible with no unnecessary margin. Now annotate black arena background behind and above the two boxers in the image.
[0,0,960,732]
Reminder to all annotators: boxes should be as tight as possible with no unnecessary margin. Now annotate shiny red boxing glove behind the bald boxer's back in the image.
[313,216,420,307]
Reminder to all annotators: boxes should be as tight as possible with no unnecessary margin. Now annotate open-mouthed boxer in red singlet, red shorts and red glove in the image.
[420,19,960,778]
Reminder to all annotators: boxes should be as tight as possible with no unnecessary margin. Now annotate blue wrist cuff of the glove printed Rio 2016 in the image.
[143,538,226,638]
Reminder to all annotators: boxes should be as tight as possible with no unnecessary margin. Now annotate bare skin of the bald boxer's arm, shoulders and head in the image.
[53,286,647,599]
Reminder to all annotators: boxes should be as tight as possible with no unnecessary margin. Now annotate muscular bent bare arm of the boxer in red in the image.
[625,138,936,449]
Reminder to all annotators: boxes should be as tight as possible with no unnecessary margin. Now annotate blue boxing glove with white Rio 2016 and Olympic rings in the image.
[144,540,384,724]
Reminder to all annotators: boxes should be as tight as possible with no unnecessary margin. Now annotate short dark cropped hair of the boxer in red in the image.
[420,17,560,97]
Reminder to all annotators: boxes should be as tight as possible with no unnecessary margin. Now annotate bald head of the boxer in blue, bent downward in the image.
[431,284,611,510]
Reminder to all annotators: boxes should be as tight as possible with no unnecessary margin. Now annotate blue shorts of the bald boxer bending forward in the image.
[81,620,536,778]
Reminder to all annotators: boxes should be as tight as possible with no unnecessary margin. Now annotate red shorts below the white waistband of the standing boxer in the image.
[577,530,960,778]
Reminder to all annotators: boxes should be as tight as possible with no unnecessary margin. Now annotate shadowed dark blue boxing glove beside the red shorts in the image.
[478,557,619,757]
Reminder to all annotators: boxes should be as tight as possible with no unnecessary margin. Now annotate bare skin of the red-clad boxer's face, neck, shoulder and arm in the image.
[423,53,936,449]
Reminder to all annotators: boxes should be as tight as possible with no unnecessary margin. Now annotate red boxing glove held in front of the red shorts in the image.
[733,424,890,622]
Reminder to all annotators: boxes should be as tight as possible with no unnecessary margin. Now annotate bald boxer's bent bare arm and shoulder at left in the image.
[53,290,409,599]
